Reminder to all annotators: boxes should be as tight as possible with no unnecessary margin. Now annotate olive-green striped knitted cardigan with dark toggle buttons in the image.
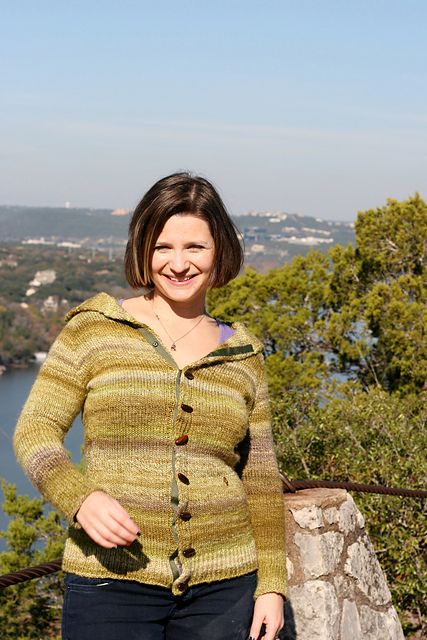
[14,293,286,597]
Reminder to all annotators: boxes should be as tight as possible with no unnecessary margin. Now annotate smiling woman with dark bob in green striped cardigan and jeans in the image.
[14,173,286,640]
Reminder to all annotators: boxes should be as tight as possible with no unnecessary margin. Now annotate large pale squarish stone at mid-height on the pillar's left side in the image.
[295,531,344,578]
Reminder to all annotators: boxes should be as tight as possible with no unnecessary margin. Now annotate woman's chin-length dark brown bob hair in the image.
[124,172,244,289]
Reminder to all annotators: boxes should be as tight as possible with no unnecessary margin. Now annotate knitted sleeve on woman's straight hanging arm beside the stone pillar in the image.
[242,354,287,598]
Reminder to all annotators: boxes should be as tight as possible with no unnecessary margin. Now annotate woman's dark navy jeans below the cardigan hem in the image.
[62,572,256,640]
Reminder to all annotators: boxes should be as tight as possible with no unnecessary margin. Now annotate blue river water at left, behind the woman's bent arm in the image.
[0,364,83,549]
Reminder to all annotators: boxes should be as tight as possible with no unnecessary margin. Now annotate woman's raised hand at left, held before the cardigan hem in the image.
[76,491,140,549]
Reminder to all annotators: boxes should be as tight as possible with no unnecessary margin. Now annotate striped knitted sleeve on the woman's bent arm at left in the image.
[13,317,103,527]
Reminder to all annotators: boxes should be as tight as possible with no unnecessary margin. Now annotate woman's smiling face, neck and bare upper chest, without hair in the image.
[123,213,218,368]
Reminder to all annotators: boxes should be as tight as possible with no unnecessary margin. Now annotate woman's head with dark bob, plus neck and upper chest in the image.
[123,173,247,368]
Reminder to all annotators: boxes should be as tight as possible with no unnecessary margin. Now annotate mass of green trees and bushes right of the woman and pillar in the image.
[210,195,427,629]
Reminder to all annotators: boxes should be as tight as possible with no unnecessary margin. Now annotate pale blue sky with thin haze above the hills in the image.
[0,0,427,220]
